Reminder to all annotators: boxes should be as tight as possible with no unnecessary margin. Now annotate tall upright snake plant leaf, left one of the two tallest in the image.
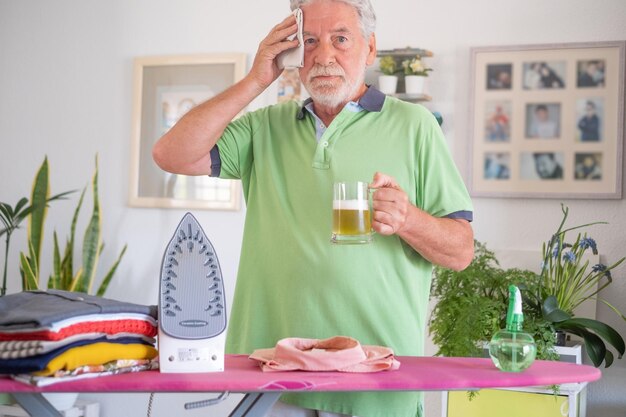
[28,157,50,270]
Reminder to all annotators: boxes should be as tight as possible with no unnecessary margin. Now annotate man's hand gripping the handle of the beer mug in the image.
[369,172,411,235]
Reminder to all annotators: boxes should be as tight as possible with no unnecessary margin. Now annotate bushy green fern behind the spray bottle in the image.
[429,241,558,359]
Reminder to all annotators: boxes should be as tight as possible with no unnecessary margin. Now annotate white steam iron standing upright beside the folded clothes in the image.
[158,213,226,373]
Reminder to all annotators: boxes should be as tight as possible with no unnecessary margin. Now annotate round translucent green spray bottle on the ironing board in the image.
[489,285,537,372]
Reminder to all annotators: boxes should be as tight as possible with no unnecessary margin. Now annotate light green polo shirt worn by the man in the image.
[212,87,472,417]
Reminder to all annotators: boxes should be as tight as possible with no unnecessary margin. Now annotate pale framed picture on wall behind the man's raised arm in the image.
[129,54,246,210]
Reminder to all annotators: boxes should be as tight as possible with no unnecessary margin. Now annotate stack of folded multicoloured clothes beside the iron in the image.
[0,290,158,385]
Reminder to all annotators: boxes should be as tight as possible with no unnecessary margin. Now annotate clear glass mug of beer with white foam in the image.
[330,181,372,244]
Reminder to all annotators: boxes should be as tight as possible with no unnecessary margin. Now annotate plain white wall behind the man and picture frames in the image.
[0,0,626,417]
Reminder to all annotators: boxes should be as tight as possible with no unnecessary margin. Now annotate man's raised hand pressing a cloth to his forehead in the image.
[248,14,298,90]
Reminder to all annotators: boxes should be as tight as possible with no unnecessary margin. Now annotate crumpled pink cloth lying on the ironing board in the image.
[249,336,400,372]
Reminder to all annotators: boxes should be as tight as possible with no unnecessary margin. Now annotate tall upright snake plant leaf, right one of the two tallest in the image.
[77,157,102,293]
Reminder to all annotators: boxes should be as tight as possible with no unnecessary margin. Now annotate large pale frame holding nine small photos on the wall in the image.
[469,41,626,199]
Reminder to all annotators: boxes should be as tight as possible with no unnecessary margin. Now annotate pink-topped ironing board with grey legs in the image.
[0,355,601,417]
